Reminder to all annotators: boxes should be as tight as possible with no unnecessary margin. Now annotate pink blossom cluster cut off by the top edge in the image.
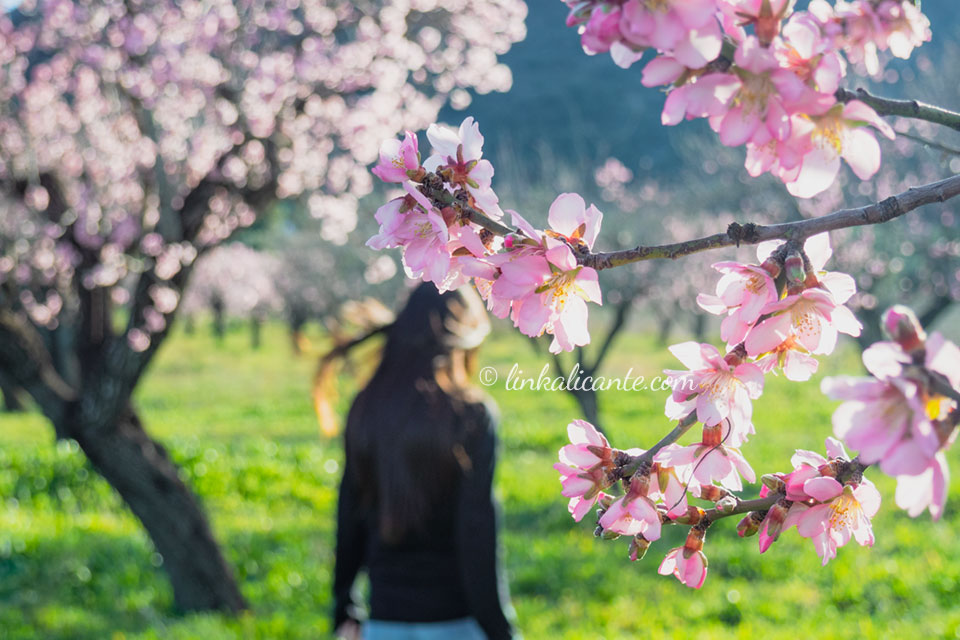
[565,0,930,198]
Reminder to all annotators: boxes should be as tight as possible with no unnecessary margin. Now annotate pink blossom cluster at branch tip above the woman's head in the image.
[367,117,603,353]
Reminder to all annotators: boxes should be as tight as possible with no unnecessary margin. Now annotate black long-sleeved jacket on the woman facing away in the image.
[333,410,512,640]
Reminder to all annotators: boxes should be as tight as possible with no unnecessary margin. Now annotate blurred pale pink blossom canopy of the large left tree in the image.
[0,0,524,344]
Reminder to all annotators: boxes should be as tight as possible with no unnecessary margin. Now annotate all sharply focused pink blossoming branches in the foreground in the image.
[368,0,960,588]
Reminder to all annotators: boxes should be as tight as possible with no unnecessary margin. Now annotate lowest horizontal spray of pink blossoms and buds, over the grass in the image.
[554,412,880,589]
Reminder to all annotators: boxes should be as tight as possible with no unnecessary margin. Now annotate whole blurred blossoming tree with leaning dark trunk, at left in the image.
[0,0,526,611]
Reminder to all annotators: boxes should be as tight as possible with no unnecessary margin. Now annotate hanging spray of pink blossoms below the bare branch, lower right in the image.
[555,228,960,588]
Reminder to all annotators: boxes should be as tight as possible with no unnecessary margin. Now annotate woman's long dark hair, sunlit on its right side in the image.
[345,283,490,542]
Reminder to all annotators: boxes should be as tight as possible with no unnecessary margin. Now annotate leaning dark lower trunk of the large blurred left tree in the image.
[60,408,246,611]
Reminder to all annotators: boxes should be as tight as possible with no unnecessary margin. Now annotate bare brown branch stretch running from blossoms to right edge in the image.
[577,175,960,270]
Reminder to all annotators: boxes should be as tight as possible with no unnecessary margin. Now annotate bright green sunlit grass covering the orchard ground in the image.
[0,327,960,640]
